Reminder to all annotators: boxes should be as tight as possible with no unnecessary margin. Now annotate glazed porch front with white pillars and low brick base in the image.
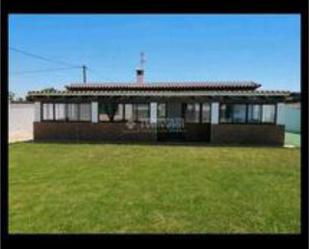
[34,99,284,145]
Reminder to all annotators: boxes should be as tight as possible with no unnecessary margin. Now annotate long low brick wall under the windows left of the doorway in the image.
[33,122,157,141]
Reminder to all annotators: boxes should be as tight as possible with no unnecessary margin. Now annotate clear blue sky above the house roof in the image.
[9,14,300,97]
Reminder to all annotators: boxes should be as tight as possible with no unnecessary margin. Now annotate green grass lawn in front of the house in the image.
[9,143,300,233]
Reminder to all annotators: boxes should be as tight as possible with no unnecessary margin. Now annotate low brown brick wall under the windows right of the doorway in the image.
[210,124,284,146]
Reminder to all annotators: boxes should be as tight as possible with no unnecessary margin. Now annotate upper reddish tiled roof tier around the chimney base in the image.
[66,81,261,91]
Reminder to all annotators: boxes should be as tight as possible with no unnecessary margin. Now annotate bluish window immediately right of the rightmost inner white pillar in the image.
[220,104,246,123]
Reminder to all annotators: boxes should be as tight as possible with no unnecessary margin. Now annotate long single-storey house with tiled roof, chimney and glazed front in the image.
[28,69,295,145]
